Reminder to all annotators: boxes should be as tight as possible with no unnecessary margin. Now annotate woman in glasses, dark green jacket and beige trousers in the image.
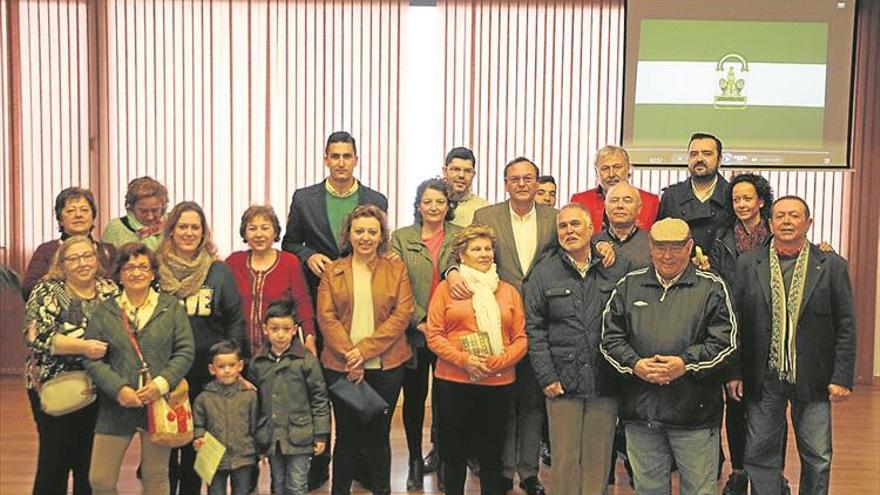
[84,243,195,495]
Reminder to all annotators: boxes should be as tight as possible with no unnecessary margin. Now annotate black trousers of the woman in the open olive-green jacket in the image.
[403,347,439,461]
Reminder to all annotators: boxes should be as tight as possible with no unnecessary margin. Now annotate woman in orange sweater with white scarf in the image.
[427,225,526,495]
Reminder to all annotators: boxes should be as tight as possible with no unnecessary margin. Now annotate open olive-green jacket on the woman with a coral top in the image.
[391,222,461,349]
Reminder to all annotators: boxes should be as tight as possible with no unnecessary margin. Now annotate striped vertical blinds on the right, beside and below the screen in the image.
[440,0,851,253]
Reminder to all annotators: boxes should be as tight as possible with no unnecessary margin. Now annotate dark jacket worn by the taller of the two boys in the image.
[248,339,330,455]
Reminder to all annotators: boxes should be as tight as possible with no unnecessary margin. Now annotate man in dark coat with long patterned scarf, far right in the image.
[727,196,856,495]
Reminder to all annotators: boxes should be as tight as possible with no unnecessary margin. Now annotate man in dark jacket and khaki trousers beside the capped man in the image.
[523,203,628,495]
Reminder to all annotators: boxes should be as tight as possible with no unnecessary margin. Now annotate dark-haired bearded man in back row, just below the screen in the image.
[657,132,729,254]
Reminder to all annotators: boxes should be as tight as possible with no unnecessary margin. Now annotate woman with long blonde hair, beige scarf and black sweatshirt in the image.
[157,201,247,495]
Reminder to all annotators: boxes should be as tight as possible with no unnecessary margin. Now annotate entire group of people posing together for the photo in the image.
[23,132,855,495]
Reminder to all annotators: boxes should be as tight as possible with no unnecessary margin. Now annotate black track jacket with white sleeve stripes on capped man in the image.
[600,264,738,429]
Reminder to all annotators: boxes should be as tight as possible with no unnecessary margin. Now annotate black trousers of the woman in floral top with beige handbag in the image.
[28,390,98,495]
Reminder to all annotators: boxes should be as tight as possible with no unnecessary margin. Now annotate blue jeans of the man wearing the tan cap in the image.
[626,423,720,495]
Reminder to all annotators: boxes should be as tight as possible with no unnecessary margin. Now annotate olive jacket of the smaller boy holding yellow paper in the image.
[193,380,258,470]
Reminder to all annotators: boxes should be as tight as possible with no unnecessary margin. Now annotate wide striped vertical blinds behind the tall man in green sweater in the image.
[101,0,405,253]
